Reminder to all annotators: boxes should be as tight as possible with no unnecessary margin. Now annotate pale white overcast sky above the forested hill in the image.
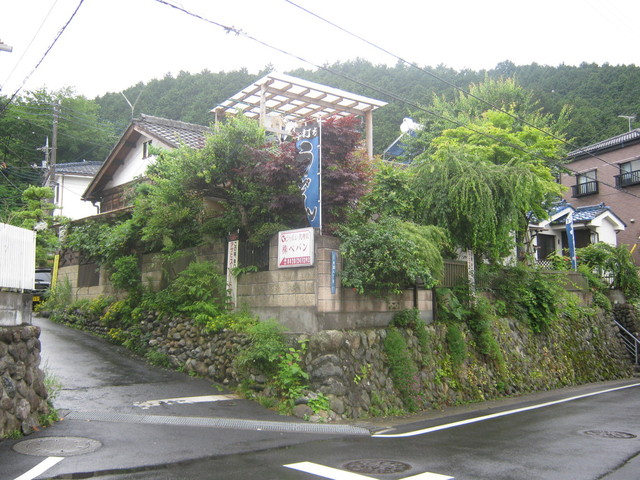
[0,0,640,98]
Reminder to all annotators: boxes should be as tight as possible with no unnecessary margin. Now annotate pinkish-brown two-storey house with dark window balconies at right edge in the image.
[560,129,640,265]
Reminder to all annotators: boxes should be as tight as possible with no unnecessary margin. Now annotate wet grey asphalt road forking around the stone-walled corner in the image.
[0,319,640,480]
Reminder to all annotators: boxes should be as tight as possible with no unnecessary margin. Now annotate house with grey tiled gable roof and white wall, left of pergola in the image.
[83,115,211,213]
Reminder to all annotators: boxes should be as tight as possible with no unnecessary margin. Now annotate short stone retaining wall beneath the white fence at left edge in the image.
[0,325,49,438]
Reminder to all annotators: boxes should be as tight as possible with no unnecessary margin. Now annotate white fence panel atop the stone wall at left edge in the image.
[0,223,36,291]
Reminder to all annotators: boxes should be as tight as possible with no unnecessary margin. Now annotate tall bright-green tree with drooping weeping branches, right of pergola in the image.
[414,80,563,260]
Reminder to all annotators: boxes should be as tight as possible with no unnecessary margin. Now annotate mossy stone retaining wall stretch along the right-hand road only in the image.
[306,316,631,418]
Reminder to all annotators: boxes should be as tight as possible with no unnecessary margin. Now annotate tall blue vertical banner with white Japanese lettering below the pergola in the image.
[296,122,322,228]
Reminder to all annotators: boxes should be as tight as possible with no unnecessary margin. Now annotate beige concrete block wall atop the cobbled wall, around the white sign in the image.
[58,231,433,333]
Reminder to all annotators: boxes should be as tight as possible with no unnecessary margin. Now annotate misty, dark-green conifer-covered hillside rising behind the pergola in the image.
[96,60,640,153]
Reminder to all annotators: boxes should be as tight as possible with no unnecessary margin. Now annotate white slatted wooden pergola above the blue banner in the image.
[211,73,387,157]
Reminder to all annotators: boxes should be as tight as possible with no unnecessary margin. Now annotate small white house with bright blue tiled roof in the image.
[529,201,626,264]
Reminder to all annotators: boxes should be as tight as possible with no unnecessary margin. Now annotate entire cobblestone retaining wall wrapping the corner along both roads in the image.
[53,306,631,420]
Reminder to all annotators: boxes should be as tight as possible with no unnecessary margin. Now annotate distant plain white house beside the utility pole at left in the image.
[44,161,102,220]
